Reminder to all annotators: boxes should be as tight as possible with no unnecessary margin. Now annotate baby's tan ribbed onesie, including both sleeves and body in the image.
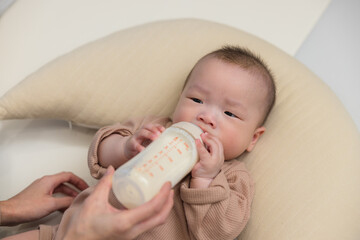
[40,118,254,240]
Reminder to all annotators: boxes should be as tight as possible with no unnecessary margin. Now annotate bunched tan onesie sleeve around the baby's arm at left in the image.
[88,117,171,179]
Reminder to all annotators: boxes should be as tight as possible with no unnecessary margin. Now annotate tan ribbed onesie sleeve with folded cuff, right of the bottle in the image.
[180,160,254,239]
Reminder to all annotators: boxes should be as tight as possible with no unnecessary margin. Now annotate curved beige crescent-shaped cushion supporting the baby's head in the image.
[0,20,360,240]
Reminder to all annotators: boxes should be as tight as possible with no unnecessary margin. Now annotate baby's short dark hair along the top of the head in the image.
[184,45,276,125]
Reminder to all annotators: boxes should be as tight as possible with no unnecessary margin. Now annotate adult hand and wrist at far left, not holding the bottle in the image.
[0,172,88,226]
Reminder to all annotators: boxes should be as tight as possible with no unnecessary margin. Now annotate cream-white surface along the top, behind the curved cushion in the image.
[0,0,330,96]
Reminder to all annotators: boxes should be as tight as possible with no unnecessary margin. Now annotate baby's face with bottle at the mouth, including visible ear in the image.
[173,57,266,160]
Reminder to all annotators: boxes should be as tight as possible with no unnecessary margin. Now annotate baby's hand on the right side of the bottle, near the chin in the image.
[190,133,224,188]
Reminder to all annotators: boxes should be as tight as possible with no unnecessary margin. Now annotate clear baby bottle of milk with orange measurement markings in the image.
[112,122,202,209]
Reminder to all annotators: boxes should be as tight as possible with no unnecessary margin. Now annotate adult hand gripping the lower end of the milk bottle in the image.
[59,166,173,240]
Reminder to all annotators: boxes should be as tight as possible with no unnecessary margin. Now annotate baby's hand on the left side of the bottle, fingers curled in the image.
[124,123,165,159]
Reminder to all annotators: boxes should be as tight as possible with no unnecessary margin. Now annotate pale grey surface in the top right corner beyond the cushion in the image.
[295,0,360,130]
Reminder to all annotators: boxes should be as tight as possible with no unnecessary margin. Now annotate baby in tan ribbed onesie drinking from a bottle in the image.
[89,46,275,240]
